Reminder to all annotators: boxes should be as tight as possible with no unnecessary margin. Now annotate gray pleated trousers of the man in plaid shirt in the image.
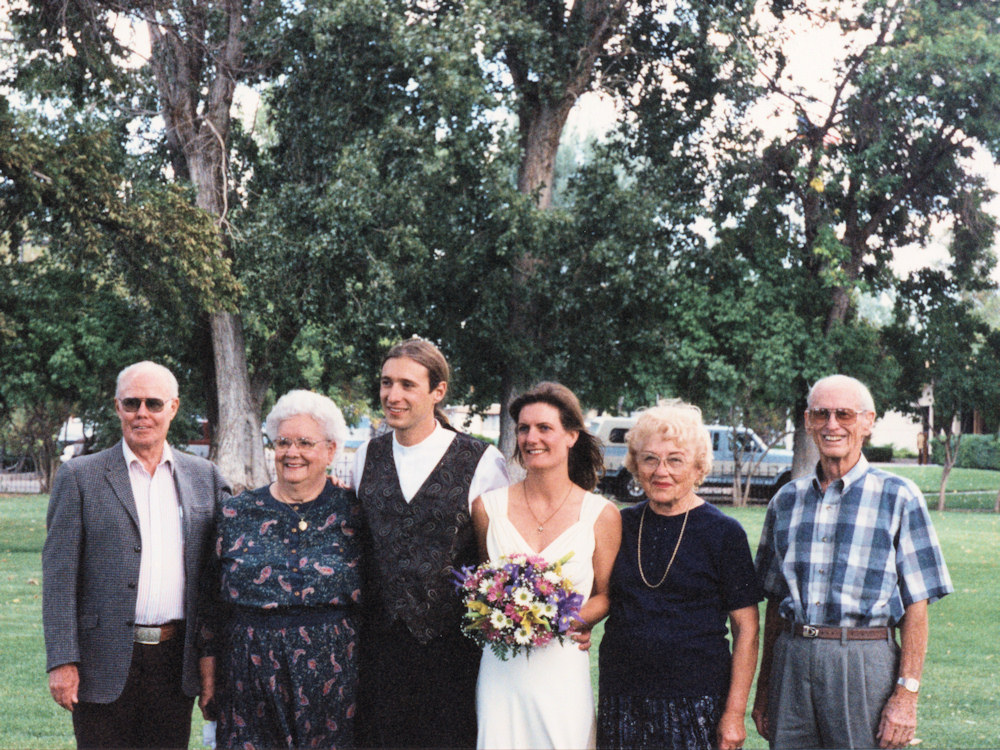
[768,632,899,750]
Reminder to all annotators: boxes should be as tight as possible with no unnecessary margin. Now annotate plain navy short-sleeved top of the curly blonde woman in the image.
[599,502,762,698]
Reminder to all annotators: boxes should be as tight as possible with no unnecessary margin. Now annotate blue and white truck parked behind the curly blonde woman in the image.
[588,417,792,503]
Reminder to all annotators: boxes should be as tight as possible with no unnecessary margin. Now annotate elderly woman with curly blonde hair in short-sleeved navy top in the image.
[597,402,762,750]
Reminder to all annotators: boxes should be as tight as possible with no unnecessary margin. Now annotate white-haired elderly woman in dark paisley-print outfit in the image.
[201,391,361,748]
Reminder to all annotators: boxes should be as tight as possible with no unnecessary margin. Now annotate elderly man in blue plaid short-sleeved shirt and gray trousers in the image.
[752,375,953,748]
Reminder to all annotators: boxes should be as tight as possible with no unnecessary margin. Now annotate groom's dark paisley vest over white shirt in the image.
[358,432,486,644]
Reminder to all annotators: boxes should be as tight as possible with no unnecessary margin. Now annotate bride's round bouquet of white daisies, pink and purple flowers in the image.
[455,552,583,660]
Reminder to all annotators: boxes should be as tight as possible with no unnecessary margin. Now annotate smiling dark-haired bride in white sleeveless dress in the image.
[472,383,621,750]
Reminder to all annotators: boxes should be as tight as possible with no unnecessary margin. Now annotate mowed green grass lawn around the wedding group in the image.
[7,496,1000,748]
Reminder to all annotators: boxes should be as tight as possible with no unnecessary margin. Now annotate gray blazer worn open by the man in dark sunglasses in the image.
[42,443,229,703]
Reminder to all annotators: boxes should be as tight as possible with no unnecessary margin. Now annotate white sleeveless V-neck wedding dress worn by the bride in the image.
[476,488,608,750]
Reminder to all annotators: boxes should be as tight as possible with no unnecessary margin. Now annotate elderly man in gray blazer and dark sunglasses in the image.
[42,362,229,748]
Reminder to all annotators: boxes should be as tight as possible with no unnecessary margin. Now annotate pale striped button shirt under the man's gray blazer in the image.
[122,441,184,625]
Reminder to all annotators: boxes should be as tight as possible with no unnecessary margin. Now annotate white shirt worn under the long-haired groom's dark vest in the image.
[352,422,510,507]
